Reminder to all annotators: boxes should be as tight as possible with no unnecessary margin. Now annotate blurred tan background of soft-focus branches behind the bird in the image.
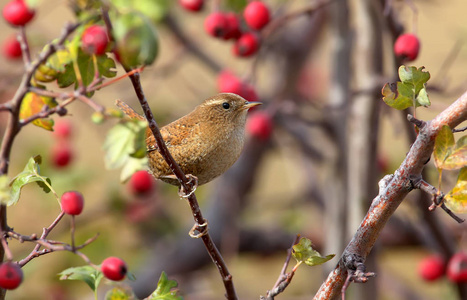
[0,0,467,300]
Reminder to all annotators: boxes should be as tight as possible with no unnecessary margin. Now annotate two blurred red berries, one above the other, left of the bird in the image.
[51,119,73,168]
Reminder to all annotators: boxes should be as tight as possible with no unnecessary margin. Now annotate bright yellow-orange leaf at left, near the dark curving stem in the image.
[19,92,57,131]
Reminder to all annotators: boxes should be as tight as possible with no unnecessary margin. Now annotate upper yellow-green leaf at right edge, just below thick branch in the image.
[433,125,467,170]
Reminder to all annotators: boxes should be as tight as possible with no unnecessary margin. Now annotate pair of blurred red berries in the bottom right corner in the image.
[418,252,467,283]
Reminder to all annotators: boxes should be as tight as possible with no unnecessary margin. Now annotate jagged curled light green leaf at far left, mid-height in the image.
[8,155,51,206]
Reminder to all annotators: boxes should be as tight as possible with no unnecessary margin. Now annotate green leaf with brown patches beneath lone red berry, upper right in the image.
[382,66,431,110]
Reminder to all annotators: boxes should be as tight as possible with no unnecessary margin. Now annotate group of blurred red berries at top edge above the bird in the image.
[179,0,270,57]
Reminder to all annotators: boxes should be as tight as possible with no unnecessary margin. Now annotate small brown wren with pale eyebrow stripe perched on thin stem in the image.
[117,93,261,186]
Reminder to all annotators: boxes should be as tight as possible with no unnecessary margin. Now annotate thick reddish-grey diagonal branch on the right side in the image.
[314,92,467,300]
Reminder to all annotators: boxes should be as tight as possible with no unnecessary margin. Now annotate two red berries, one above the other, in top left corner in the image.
[2,0,35,59]
